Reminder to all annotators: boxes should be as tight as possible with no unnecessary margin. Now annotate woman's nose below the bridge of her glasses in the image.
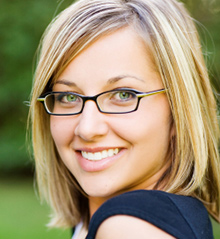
[75,100,109,141]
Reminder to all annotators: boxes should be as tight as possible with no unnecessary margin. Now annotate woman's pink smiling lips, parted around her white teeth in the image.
[75,147,125,172]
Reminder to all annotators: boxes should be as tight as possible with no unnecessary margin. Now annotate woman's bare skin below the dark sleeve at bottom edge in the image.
[96,215,175,239]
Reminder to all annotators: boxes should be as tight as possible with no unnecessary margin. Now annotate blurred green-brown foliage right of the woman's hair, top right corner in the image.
[183,0,220,93]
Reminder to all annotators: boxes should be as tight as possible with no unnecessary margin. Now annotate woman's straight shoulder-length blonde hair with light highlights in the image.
[30,0,220,227]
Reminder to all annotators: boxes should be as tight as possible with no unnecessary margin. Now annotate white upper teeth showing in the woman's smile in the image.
[81,148,119,161]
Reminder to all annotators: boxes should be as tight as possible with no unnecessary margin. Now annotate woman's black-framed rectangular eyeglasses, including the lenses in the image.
[37,88,167,116]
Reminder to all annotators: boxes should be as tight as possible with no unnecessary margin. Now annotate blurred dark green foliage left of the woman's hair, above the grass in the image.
[0,0,73,174]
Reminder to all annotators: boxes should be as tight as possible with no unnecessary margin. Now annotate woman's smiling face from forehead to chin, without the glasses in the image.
[50,28,171,200]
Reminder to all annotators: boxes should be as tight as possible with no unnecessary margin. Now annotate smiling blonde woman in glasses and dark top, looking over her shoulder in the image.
[30,0,220,239]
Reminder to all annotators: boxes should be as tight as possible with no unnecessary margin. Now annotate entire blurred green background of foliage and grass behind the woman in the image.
[0,0,220,239]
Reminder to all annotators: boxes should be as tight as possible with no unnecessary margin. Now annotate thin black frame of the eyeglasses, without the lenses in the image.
[37,88,167,116]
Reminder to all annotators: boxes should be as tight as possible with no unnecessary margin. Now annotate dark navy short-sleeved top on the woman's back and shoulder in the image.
[86,190,213,239]
